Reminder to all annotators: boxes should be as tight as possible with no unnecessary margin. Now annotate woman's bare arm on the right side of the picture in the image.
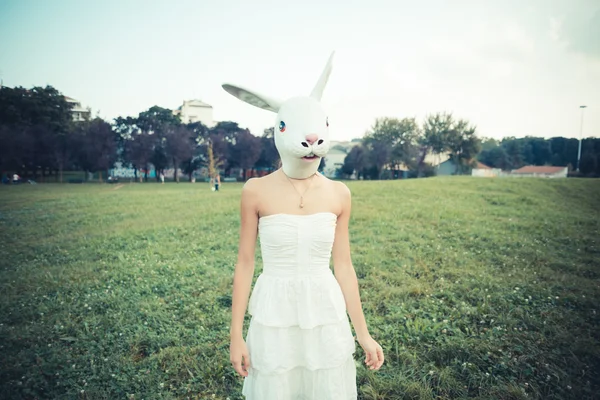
[333,183,384,369]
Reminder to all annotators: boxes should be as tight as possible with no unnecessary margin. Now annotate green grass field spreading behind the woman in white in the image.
[0,177,600,400]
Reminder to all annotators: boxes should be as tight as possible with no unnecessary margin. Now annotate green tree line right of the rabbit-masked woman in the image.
[340,113,600,179]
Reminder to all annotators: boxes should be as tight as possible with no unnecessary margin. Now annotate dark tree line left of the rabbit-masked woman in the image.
[0,86,279,181]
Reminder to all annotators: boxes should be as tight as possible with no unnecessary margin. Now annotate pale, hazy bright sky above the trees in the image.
[0,0,600,140]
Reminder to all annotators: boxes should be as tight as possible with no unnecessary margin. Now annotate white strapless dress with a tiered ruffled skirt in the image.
[242,212,357,400]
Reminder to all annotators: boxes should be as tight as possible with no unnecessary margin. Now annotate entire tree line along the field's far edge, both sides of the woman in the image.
[0,86,600,181]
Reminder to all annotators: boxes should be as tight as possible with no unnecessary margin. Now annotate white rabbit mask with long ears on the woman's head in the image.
[223,53,333,179]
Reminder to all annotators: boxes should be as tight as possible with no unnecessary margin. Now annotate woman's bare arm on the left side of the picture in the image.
[230,179,258,376]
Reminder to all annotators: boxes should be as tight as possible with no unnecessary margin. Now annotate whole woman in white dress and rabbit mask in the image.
[223,51,384,400]
